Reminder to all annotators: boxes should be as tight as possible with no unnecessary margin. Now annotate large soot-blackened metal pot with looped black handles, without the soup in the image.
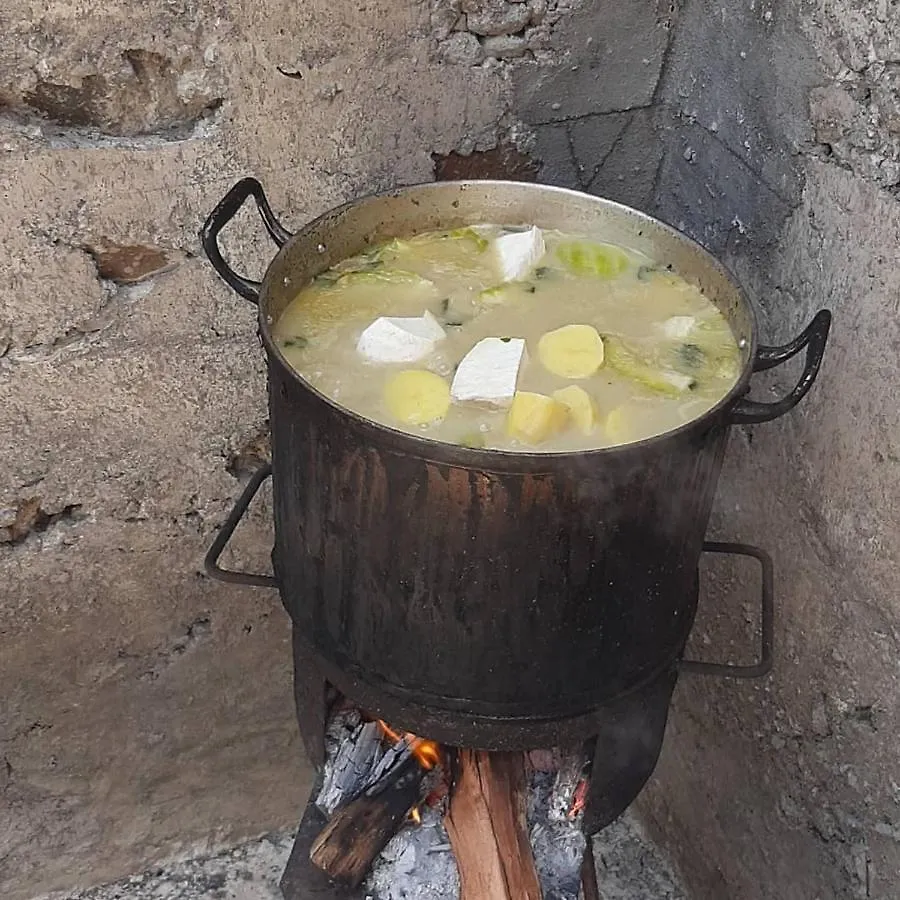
[202,179,831,748]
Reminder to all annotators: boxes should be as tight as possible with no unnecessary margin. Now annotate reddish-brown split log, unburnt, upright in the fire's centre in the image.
[444,750,543,900]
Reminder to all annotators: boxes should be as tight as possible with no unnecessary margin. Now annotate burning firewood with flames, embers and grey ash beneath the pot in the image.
[298,709,595,900]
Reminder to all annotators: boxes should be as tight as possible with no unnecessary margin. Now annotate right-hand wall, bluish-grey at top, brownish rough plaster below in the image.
[639,0,900,900]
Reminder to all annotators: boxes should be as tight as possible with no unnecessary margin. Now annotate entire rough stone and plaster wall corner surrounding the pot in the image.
[0,0,900,900]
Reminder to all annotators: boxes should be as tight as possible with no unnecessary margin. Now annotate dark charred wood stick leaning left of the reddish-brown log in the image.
[309,753,425,888]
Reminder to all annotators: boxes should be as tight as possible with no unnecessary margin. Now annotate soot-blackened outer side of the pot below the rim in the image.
[269,366,726,730]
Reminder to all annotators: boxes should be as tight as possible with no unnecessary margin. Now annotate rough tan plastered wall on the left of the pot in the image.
[0,0,507,900]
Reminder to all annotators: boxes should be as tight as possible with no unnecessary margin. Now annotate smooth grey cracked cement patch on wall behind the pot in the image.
[512,0,677,212]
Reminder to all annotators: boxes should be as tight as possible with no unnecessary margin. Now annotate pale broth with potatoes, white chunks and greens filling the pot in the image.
[274,225,741,452]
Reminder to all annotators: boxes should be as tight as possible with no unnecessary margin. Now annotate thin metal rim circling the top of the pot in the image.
[258,179,759,471]
